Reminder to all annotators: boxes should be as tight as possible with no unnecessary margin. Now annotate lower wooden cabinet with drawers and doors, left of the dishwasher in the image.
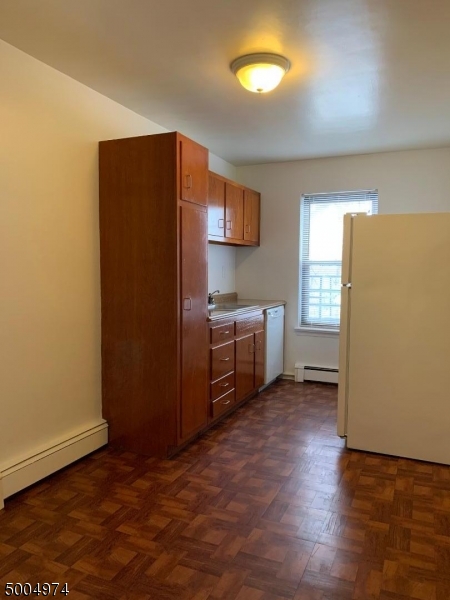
[210,311,264,420]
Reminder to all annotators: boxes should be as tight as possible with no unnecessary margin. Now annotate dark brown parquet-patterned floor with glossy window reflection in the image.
[0,381,450,600]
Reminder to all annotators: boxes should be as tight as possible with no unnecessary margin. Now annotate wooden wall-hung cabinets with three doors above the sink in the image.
[208,172,260,246]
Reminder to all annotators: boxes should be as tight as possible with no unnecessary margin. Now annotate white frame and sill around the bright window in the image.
[295,189,378,338]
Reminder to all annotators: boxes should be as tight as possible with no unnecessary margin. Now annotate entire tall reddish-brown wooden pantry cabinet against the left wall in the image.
[99,133,209,456]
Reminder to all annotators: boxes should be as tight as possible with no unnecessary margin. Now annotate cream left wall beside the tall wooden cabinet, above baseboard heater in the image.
[0,41,234,474]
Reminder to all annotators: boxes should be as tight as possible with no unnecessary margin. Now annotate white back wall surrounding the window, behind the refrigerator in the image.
[236,148,450,374]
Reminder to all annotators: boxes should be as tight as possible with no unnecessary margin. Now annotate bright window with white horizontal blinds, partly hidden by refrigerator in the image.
[299,190,378,332]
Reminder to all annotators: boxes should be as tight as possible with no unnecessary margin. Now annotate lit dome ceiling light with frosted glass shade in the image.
[230,53,291,94]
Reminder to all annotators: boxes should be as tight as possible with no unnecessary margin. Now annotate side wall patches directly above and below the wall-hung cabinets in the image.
[208,155,237,294]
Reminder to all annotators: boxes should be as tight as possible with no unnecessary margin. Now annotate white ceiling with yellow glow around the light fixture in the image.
[0,0,450,165]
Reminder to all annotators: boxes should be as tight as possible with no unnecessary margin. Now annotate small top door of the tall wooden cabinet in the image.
[180,137,208,206]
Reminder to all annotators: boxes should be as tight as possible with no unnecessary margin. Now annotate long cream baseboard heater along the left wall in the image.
[0,421,108,509]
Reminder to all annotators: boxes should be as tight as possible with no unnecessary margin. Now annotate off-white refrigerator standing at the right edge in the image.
[338,213,450,464]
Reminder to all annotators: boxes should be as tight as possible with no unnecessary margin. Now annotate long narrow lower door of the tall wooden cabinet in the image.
[179,205,209,439]
